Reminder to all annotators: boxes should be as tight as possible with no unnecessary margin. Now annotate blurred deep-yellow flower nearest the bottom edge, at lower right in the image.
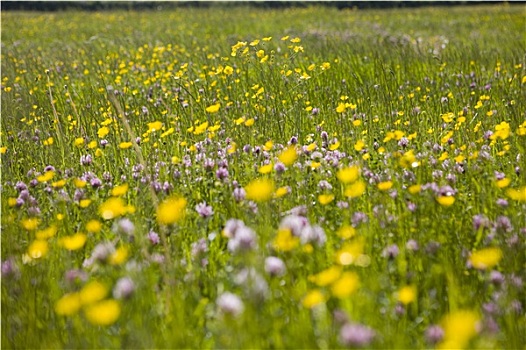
[438,310,480,349]
